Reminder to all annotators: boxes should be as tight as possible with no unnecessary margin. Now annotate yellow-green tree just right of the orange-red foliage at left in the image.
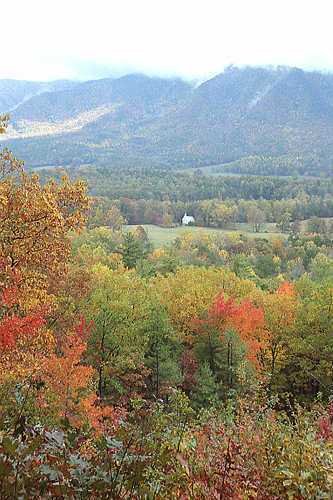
[82,264,152,398]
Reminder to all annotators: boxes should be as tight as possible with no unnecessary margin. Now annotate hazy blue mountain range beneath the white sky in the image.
[0,67,333,175]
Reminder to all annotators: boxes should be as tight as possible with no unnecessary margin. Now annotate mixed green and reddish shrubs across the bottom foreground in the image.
[0,392,333,499]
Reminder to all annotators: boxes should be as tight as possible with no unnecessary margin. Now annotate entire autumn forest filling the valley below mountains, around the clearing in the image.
[0,111,333,500]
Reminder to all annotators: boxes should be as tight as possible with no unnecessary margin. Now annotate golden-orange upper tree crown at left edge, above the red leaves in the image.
[0,151,89,309]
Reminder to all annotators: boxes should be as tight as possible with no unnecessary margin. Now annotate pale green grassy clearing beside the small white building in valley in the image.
[126,223,286,247]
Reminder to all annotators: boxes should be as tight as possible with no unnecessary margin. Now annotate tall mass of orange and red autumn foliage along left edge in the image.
[0,119,111,432]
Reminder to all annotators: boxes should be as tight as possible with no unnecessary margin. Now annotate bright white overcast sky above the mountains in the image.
[0,0,333,80]
